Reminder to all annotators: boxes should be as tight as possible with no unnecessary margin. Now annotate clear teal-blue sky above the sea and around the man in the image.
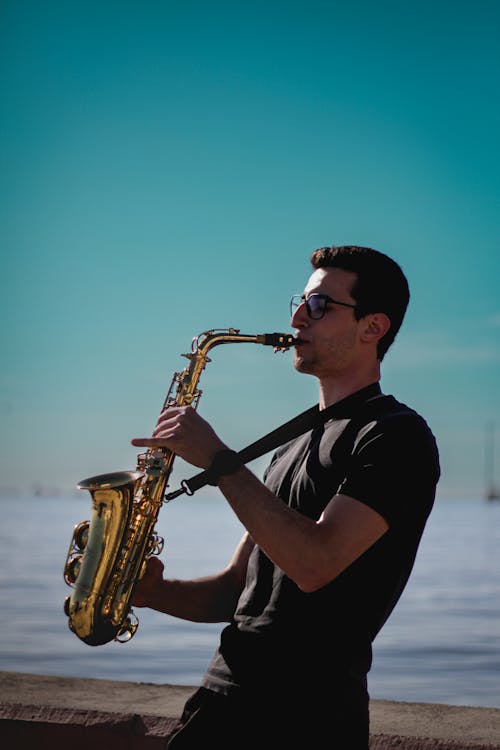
[0,0,500,496]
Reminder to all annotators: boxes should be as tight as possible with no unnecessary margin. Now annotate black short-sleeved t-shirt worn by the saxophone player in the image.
[202,384,439,693]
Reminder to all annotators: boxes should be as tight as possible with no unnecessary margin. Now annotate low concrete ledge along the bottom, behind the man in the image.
[0,672,500,750]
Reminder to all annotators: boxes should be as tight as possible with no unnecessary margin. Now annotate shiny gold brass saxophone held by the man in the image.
[64,328,294,646]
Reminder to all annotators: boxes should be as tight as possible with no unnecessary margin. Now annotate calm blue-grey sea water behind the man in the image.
[0,489,500,707]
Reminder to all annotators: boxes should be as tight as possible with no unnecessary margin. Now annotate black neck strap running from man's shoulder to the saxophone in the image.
[164,383,381,503]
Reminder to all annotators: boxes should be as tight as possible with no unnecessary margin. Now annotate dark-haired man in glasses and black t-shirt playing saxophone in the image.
[132,246,439,750]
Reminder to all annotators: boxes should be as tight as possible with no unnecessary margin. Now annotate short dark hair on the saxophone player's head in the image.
[311,245,410,361]
